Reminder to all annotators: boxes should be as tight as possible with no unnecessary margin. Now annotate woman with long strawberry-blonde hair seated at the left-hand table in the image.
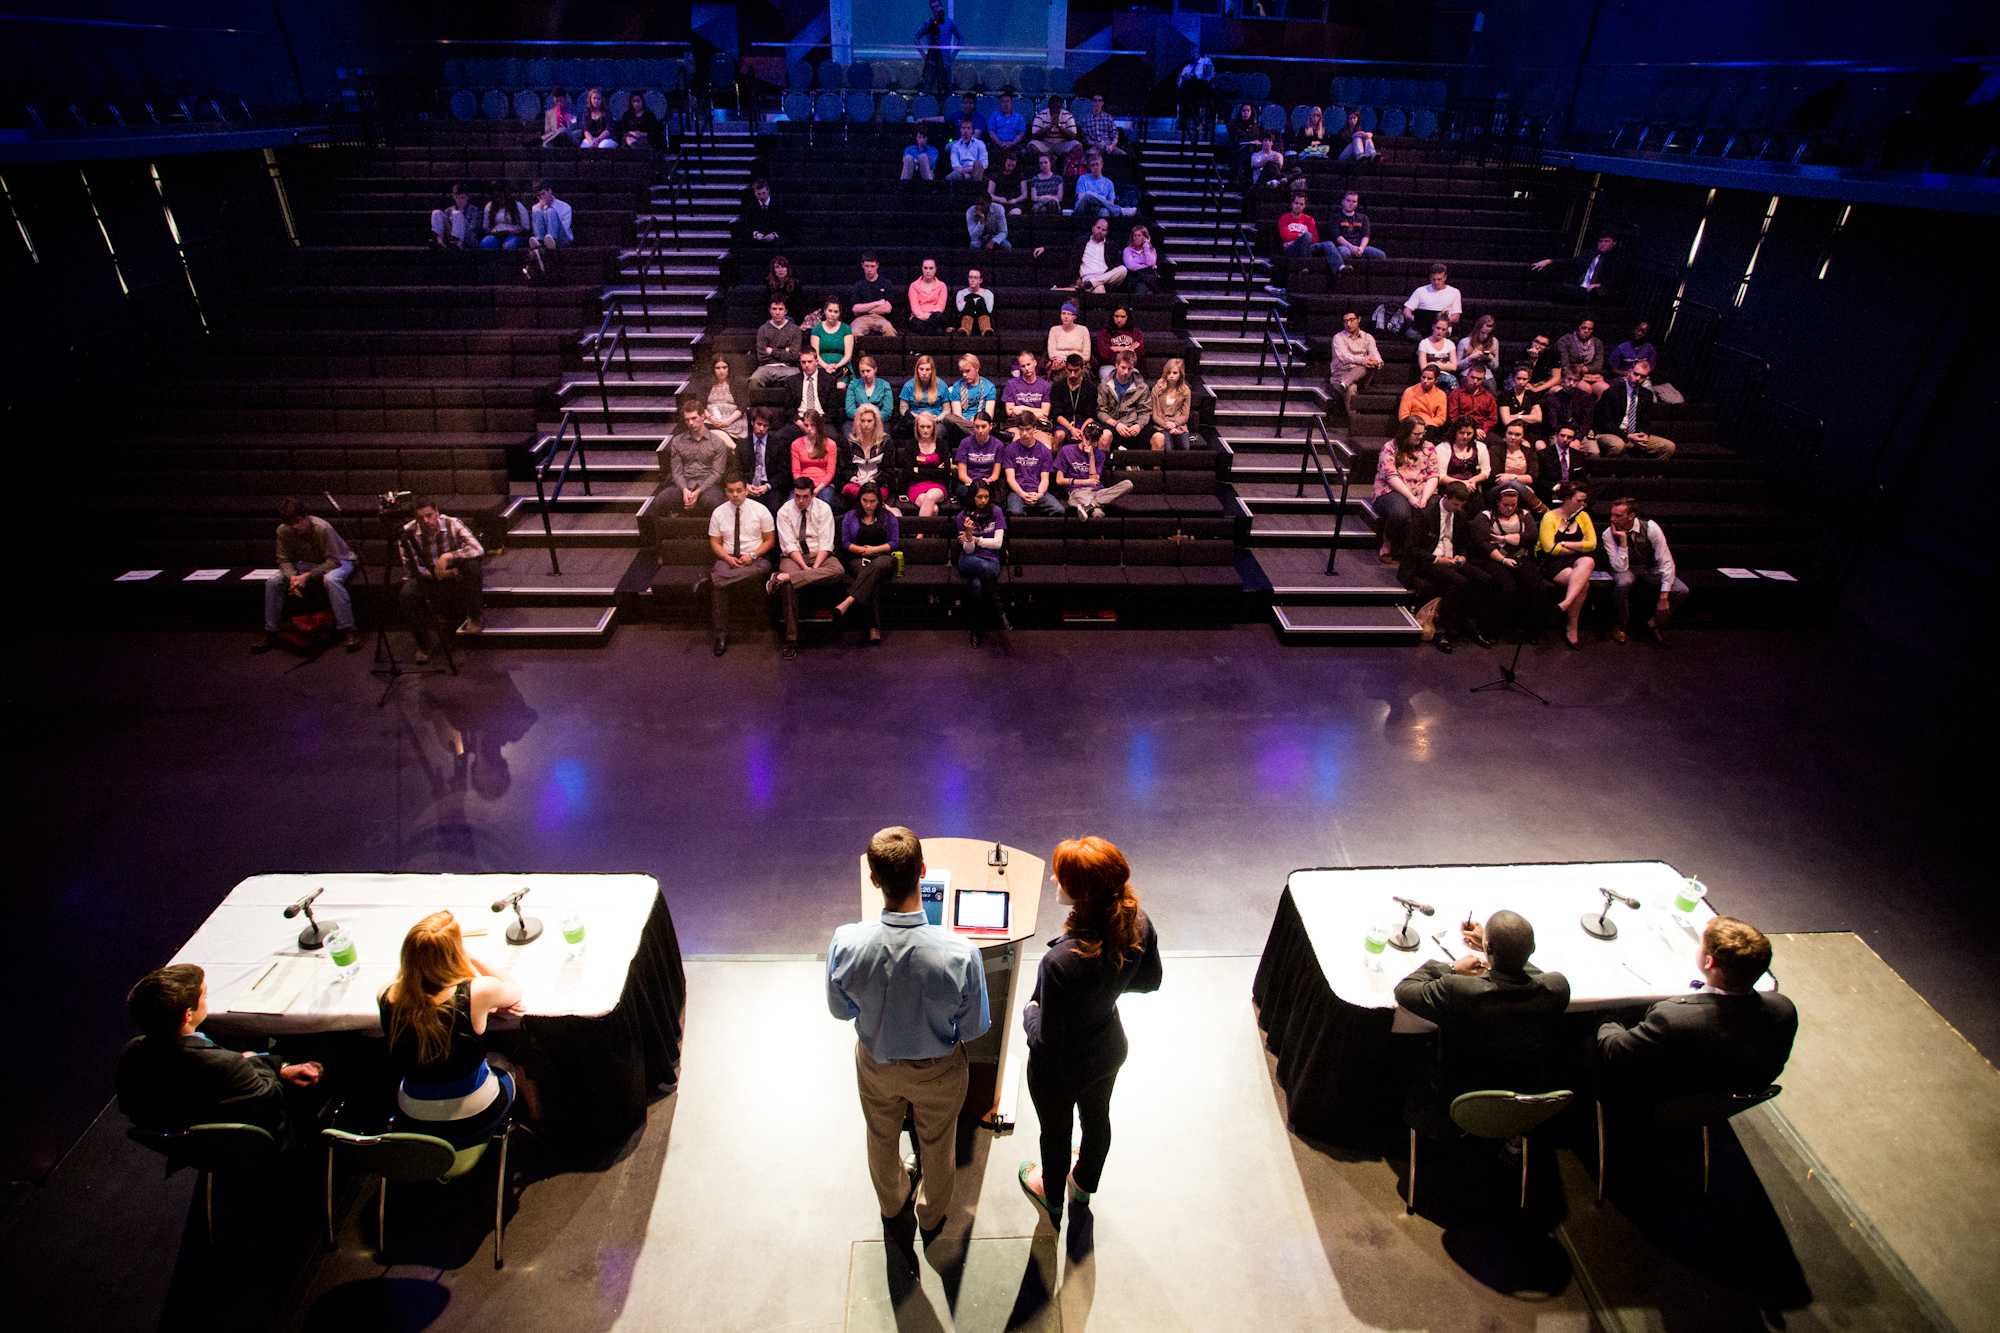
[376,913,520,1147]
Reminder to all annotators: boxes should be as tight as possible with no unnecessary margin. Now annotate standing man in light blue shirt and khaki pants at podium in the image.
[826,827,990,1239]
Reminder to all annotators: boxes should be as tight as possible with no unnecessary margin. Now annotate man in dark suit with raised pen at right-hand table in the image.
[1396,911,1570,1129]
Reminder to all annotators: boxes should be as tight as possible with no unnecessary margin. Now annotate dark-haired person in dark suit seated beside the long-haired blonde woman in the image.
[116,963,326,1145]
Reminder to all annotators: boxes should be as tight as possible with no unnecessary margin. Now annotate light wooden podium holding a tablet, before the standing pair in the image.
[860,839,1048,1133]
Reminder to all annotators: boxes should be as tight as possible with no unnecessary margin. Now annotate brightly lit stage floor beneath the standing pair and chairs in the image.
[6,937,1968,1333]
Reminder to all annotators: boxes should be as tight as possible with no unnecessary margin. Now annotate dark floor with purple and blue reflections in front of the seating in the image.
[0,626,2000,1181]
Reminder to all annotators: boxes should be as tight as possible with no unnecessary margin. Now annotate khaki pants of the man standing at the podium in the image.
[854,1041,966,1231]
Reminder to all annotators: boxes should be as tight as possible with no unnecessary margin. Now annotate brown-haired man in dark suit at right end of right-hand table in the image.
[1596,917,1798,1103]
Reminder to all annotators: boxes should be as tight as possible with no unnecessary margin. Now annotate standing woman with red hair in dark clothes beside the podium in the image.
[1020,837,1160,1229]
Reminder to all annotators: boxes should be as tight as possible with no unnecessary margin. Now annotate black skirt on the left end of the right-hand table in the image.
[1250,887,1408,1149]
